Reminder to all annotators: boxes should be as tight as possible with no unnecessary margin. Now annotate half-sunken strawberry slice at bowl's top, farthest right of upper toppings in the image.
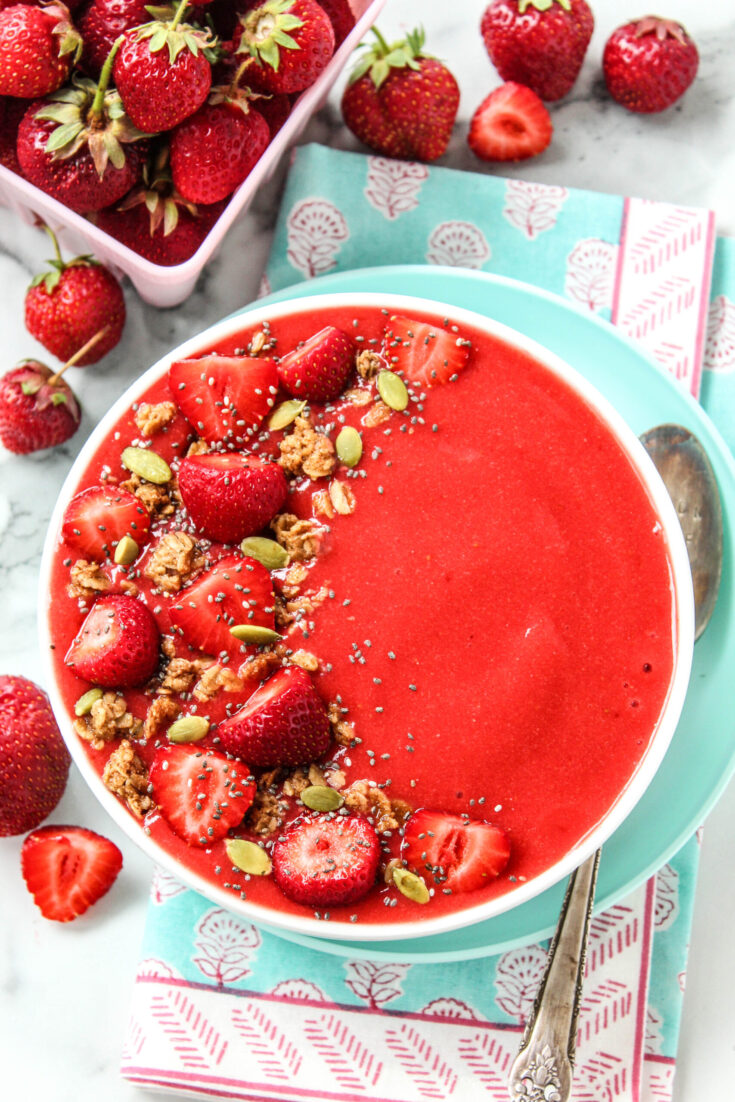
[382,314,469,389]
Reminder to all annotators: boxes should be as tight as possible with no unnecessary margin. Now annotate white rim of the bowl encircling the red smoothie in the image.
[37,291,694,942]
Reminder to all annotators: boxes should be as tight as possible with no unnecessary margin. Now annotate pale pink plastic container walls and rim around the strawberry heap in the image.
[0,0,386,306]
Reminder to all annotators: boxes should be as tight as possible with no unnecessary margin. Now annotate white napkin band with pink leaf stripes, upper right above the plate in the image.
[613,199,714,397]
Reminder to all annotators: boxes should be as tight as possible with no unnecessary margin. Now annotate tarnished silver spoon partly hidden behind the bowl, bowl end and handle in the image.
[508,424,723,1102]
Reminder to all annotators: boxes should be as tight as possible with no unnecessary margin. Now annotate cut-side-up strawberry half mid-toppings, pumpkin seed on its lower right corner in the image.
[169,554,275,657]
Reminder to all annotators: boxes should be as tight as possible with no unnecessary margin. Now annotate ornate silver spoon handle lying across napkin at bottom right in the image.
[508,850,599,1102]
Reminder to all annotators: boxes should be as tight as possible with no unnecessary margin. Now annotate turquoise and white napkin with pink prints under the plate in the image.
[121,145,735,1102]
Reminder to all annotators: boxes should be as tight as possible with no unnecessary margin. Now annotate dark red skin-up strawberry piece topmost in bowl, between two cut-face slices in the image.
[278,325,355,402]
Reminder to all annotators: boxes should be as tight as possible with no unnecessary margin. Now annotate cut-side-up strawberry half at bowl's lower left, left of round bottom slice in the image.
[149,746,256,845]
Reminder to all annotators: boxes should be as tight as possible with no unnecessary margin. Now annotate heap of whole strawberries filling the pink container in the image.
[0,0,355,264]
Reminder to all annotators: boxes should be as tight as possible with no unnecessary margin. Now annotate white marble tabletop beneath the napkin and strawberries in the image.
[0,0,735,1102]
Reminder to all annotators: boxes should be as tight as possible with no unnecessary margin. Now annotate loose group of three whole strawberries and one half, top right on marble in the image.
[342,0,699,161]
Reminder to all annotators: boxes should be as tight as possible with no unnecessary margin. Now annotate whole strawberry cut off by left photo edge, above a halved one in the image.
[0,674,72,838]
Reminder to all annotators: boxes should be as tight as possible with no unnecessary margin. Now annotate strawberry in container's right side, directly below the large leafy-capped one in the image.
[171,102,270,203]
